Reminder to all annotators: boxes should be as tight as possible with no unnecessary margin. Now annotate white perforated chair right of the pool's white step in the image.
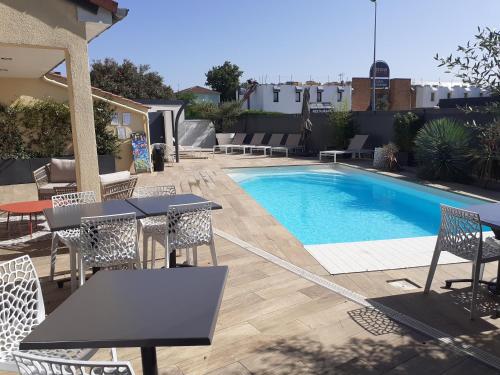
[424,204,500,319]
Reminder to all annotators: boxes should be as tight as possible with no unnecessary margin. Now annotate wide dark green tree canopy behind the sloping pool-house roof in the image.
[90,58,174,99]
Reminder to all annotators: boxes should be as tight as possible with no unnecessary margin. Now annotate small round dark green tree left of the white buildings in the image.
[205,61,243,102]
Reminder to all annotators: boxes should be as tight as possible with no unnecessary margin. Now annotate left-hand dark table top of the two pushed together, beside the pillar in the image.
[43,200,146,232]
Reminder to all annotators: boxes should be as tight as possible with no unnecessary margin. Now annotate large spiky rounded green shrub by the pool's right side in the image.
[415,118,471,182]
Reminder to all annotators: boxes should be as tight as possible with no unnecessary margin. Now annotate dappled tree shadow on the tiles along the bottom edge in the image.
[252,332,495,375]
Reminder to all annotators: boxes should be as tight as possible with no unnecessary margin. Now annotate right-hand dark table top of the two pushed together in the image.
[126,194,222,216]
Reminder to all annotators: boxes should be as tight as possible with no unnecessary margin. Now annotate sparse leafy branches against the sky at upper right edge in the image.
[434,27,500,95]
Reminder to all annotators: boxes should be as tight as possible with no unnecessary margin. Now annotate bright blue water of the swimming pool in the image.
[228,166,483,245]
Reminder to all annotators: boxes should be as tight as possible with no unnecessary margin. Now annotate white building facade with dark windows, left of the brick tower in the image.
[238,83,352,114]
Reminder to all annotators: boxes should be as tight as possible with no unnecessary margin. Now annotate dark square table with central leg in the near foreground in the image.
[19,266,228,375]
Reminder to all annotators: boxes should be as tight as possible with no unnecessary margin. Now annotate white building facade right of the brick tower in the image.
[413,84,490,108]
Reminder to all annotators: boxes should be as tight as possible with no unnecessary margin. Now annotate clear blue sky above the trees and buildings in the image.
[84,0,500,91]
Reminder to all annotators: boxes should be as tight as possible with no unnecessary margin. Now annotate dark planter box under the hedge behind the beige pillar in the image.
[0,155,116,185]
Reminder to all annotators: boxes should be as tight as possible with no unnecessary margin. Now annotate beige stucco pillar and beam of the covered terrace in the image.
[0,0,105,196]
